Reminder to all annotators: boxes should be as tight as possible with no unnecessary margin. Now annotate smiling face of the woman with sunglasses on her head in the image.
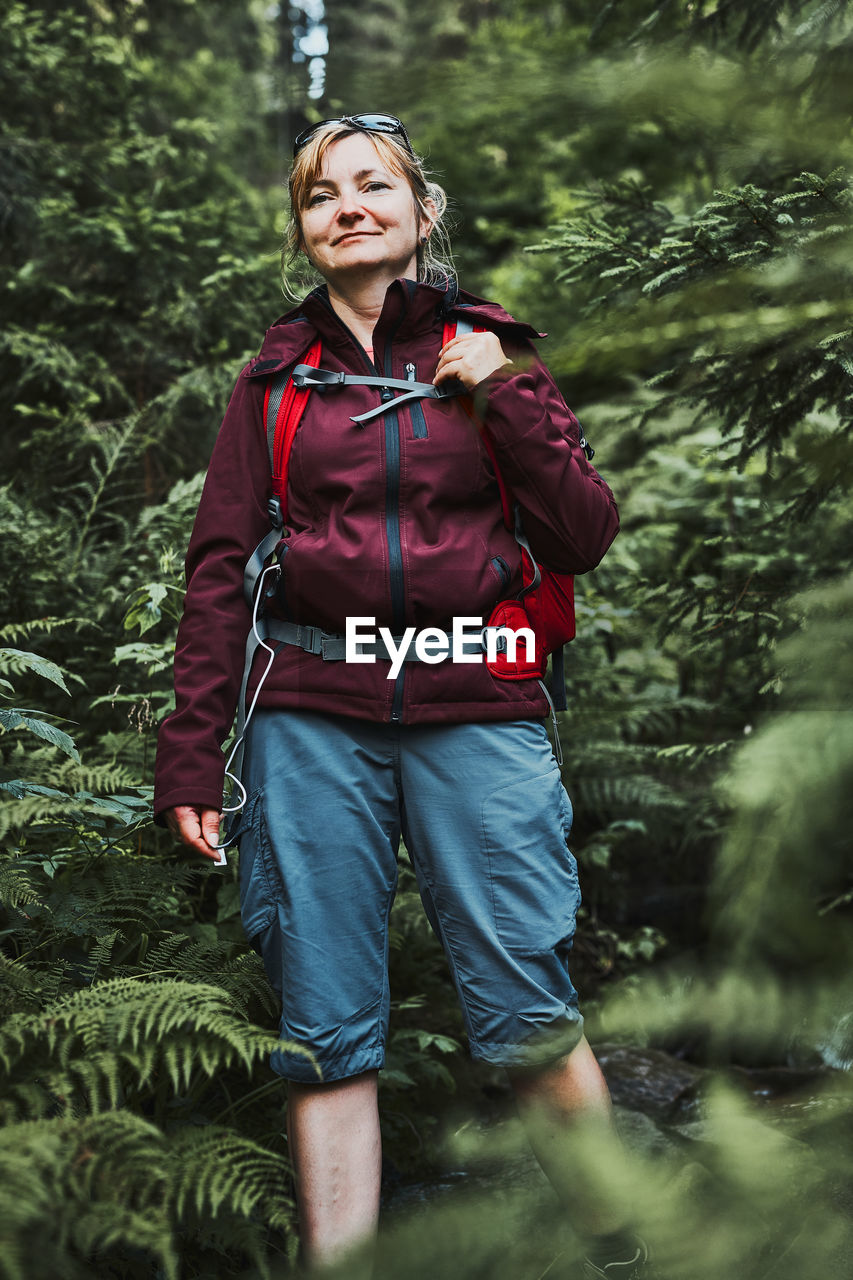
[301,133,425,283]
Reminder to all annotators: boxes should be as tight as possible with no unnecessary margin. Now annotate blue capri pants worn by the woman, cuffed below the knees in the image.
[240,709,583,1083]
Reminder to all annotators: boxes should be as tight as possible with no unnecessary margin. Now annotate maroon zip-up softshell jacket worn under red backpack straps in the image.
[155,280,619,814]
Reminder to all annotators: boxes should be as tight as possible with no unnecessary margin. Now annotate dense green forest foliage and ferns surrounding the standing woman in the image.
[0,0,853,1280]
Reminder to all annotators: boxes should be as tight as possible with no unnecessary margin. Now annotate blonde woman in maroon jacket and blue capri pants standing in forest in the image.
[156,115,639,1276]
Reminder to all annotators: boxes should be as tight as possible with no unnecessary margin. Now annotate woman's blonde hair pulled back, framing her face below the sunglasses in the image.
[282,122,453,298]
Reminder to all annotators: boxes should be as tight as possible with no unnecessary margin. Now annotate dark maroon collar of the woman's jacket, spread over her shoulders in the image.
[245,279,544,378]
